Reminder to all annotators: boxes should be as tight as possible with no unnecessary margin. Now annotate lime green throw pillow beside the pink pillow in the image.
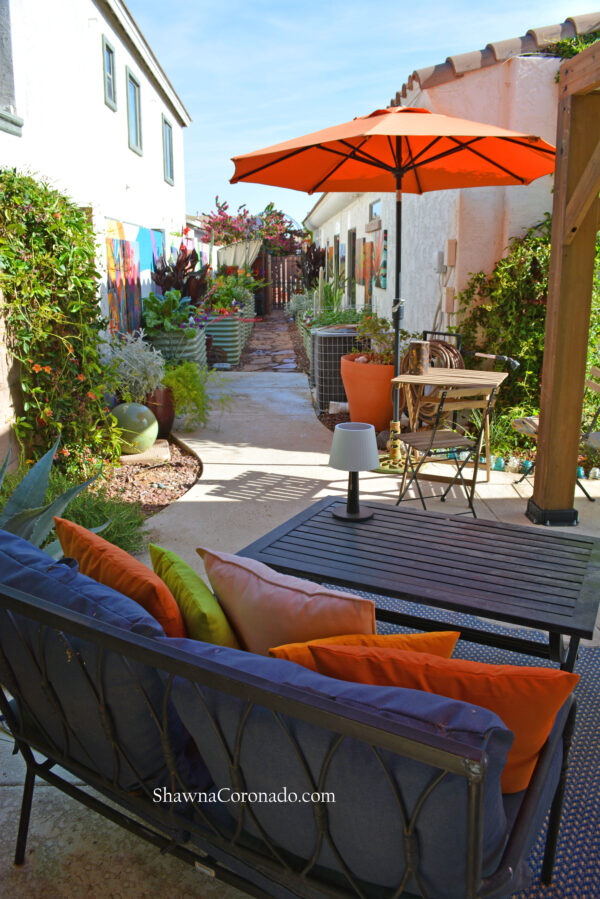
[150,543,240,649]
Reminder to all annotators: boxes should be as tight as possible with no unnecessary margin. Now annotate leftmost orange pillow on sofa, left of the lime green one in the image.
[54,518,187,637]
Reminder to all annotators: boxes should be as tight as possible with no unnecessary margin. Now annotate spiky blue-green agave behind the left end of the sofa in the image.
[0,437,110,558]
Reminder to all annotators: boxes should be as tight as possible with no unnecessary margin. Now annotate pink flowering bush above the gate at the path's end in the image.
[200,197,308,256]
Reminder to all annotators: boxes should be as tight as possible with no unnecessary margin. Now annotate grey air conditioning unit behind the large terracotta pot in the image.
[310,325,356,412]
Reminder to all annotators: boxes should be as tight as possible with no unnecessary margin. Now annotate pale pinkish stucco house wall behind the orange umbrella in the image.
[402,56,559,326]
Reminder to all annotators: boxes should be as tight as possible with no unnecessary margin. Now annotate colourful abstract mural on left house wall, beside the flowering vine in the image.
[106,219,164,333]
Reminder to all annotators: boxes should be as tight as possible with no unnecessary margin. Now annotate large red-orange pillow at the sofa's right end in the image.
[309,644,579,793]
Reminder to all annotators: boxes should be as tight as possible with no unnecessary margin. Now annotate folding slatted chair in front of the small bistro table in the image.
[396,385,496,518]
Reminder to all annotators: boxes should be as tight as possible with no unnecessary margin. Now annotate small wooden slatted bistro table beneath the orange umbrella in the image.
[392,367,508,483]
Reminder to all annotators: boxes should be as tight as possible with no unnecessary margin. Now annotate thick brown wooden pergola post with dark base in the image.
[527,44,600,525]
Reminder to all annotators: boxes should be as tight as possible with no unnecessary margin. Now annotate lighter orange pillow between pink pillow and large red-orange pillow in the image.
[269,631,460,671]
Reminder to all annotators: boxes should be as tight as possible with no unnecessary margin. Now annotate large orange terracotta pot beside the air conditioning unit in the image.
[340,353,394,431]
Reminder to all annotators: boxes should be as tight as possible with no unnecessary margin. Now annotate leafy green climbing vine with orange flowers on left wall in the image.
[0,168,119,469]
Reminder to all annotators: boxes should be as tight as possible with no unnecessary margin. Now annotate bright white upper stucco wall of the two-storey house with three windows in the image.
[0,0,185,258]
